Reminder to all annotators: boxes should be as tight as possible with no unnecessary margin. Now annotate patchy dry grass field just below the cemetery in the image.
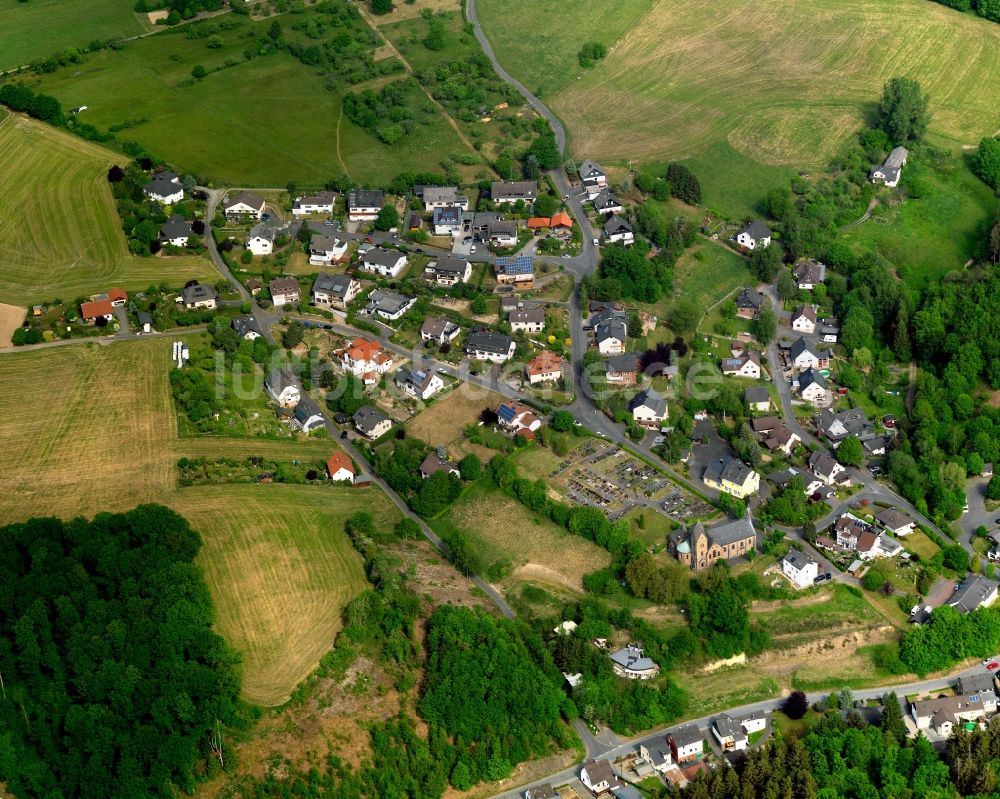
[431,480,611,591]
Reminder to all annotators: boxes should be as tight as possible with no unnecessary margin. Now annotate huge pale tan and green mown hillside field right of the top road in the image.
[480,0,1000,180]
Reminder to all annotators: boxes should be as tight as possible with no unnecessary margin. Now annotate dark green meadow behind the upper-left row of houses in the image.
[38,12,478,186]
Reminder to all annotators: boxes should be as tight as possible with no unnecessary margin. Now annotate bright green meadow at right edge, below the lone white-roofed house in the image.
[842,156,1000,288]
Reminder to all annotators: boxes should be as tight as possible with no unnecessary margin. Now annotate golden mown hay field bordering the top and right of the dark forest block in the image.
[0,339,397,705]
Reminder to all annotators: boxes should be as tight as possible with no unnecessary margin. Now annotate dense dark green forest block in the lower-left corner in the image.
[0,505,240,799]
